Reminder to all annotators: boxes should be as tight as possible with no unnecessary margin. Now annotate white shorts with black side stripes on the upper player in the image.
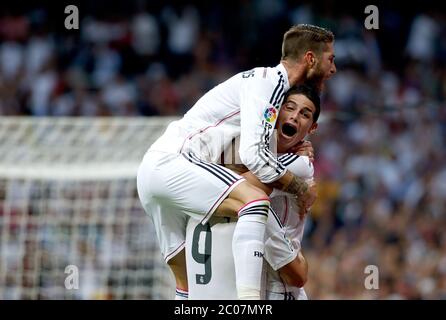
[137,151,245,262]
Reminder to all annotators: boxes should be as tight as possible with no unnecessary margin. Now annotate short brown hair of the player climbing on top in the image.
[282,24,334,59]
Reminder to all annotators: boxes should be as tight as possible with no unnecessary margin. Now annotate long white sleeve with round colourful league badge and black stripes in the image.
[239,71,286,183]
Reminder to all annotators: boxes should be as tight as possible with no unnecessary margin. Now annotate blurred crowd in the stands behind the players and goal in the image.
[0,0,446,299]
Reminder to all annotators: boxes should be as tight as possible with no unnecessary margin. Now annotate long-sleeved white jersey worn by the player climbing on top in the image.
[149,64,289,183]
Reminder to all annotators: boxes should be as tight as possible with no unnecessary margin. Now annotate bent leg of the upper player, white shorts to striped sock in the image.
[138,154,270,299]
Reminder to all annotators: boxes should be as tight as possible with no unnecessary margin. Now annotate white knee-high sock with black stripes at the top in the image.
[232,199,270,300]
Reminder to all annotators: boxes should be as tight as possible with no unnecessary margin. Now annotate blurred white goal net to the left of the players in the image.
[0,117,175,299]
